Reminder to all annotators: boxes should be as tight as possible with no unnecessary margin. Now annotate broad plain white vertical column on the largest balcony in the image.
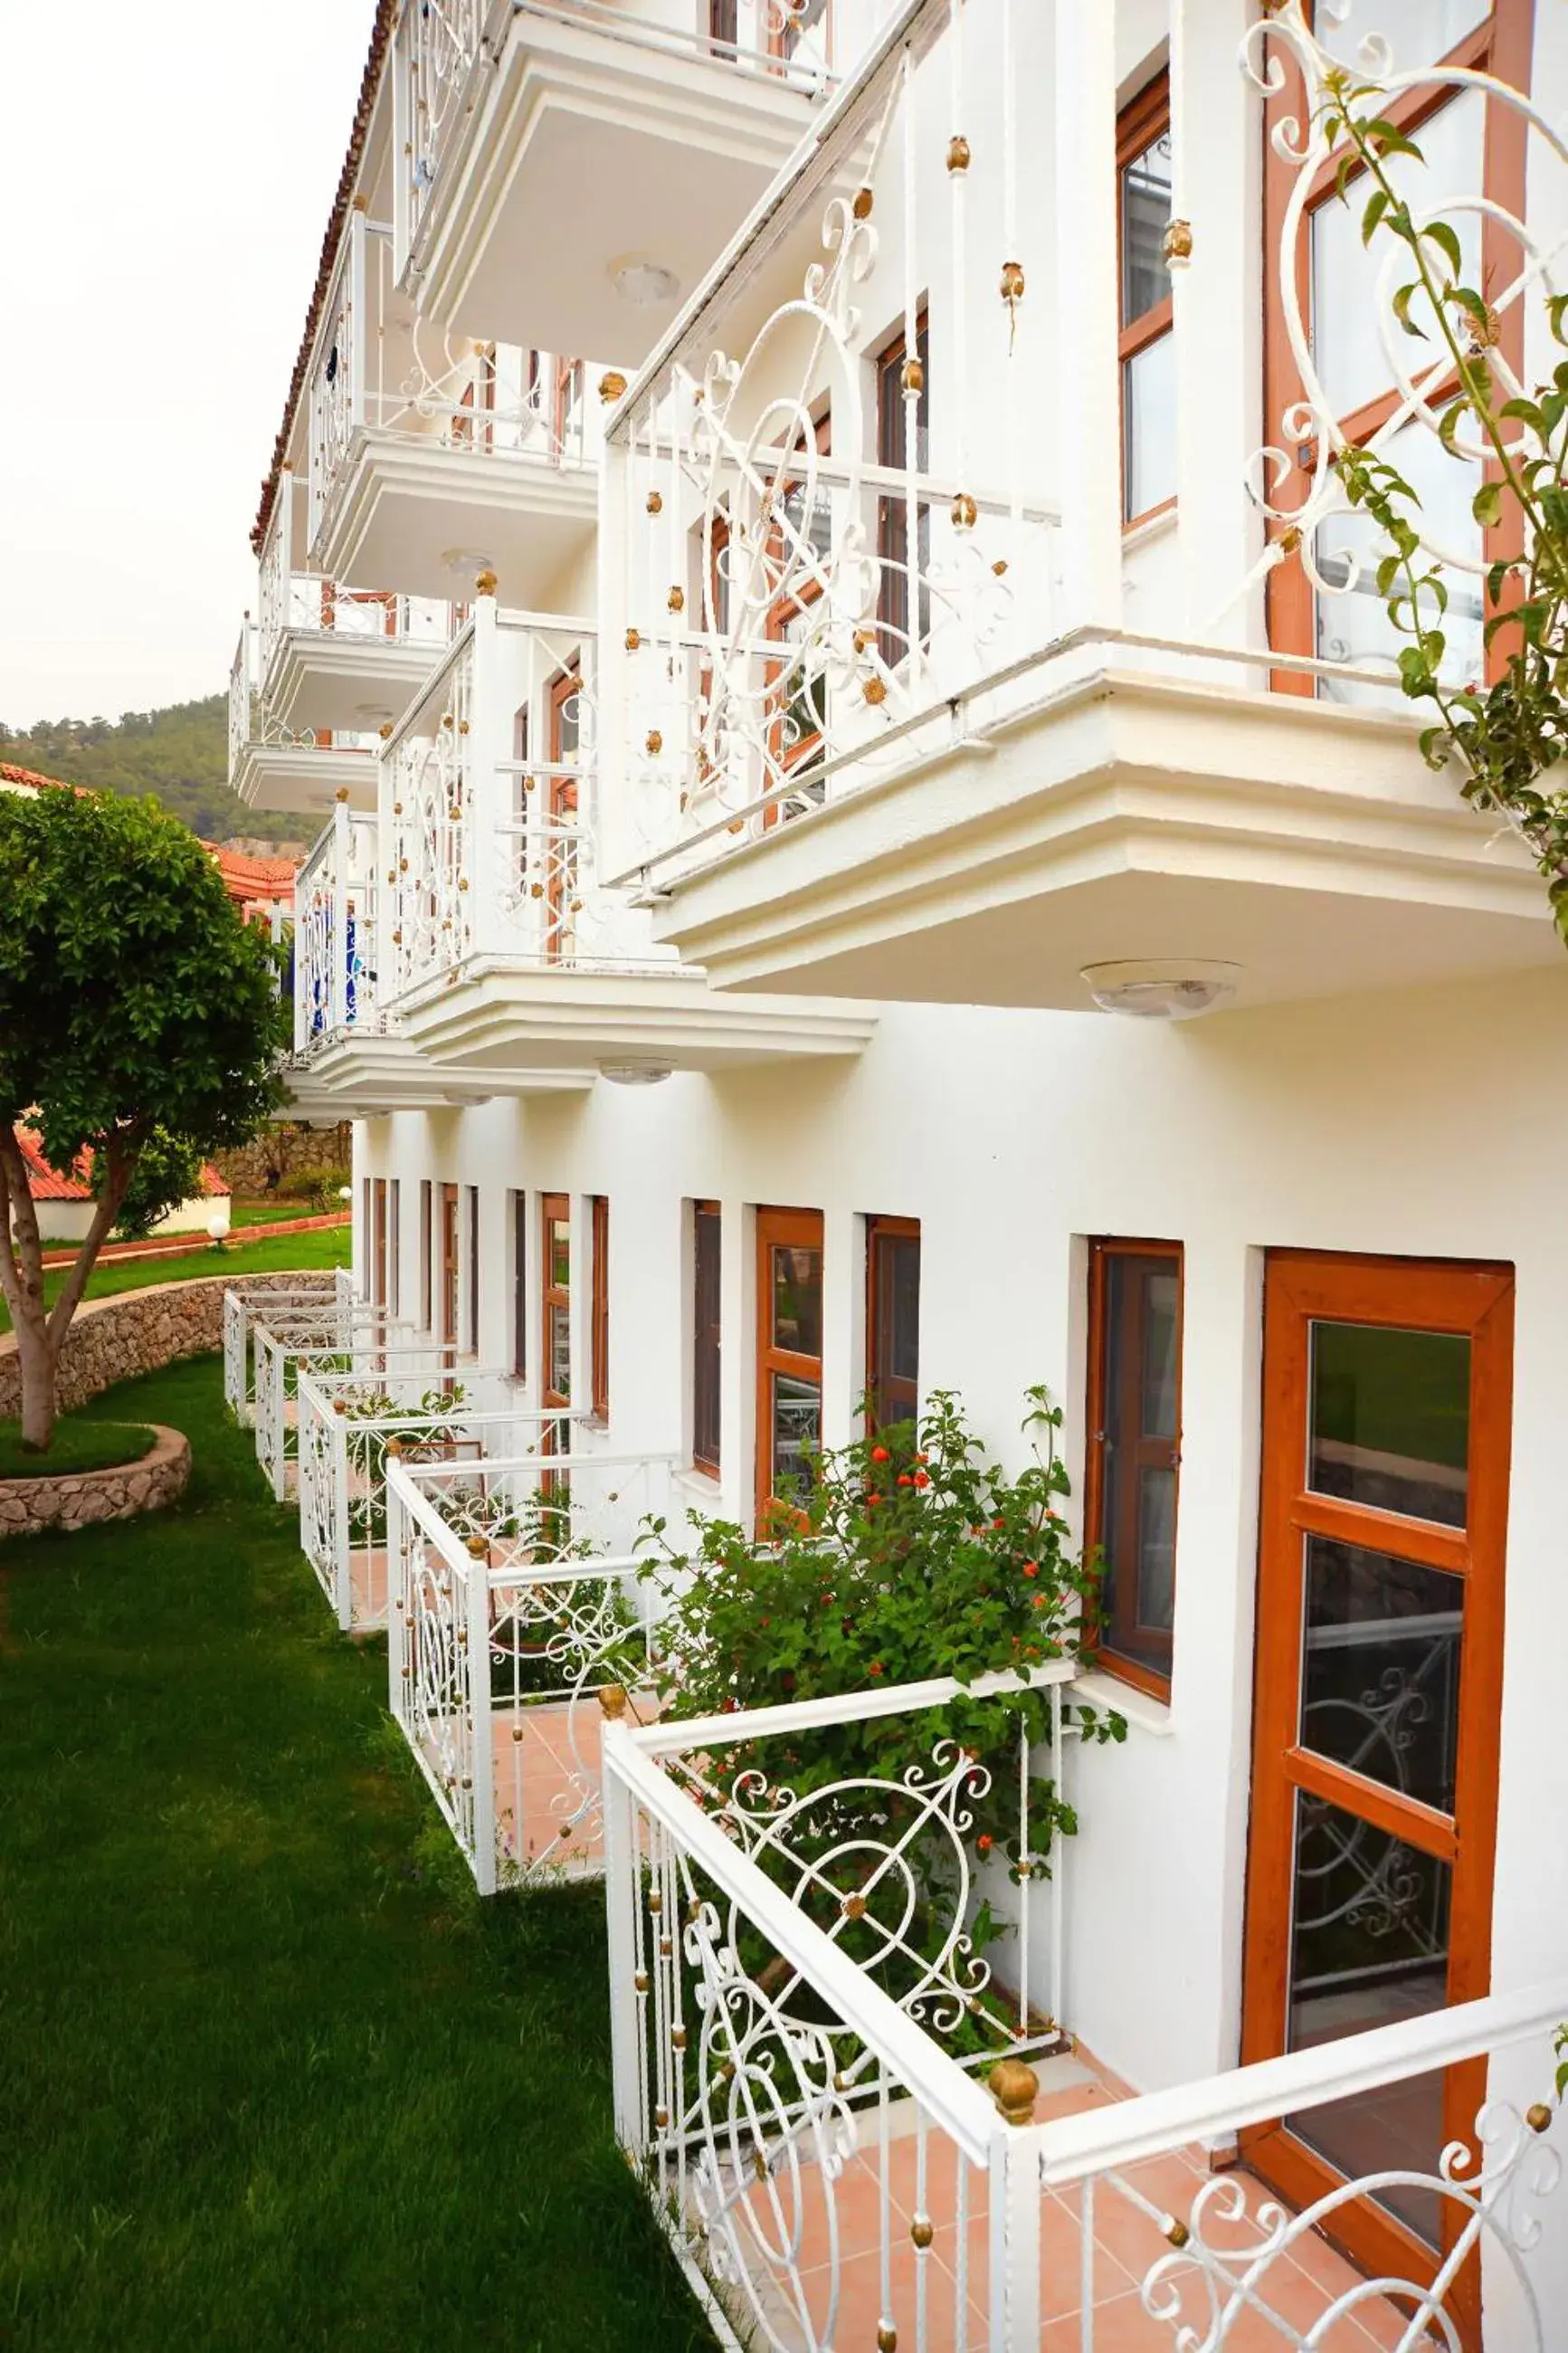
[1053,0,1121,628]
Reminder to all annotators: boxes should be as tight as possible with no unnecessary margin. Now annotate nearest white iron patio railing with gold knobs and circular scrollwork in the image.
[602,1668,1568,2353]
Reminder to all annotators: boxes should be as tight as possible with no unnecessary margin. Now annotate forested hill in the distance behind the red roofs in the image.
[0,694,315,843]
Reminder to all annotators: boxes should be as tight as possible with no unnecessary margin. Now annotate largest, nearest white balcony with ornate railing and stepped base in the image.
[604,5,1561,1009]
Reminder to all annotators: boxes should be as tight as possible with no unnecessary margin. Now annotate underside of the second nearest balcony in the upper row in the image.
[313,431,600,605]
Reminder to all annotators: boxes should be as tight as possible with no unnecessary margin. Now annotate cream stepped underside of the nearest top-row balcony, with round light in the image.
[409,14,818,357]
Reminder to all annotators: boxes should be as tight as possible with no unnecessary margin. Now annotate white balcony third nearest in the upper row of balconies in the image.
[256,471,456,734]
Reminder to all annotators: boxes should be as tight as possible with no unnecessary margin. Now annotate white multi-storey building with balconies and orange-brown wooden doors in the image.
[233,0,1568,2353]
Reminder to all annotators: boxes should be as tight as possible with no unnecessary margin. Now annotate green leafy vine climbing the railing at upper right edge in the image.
[1326,73,1568,941]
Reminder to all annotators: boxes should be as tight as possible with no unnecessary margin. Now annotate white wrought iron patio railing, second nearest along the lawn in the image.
[385,1452,672,1894]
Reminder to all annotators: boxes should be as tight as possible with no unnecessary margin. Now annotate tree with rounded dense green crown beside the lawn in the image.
[0,788,287,1450]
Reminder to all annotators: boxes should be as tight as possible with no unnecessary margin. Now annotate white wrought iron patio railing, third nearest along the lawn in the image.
[296,1365,571,1631]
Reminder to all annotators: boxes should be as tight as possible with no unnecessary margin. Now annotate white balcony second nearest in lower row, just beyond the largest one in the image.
[378,595,872,1091]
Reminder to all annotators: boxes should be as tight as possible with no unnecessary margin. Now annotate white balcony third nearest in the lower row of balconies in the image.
[290,803,593,1120]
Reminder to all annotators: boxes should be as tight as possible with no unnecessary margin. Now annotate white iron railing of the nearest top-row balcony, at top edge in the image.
[393,0,860,280]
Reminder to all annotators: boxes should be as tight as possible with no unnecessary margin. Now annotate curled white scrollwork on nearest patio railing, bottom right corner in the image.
[1133,2101,1561,2353]
